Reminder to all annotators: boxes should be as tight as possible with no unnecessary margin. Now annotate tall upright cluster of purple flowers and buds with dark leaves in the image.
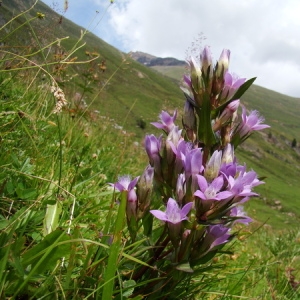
[110,47,269,275]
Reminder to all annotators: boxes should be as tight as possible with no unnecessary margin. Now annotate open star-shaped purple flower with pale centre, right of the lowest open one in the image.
[194,175,232,200]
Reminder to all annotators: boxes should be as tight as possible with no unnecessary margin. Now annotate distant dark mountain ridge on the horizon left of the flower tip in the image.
[129,51,186,67]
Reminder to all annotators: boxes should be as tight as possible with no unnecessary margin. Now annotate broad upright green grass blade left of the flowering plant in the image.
[102,191,127,300]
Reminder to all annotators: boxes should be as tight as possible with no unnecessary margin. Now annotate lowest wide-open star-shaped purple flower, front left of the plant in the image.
[150,198,193,224]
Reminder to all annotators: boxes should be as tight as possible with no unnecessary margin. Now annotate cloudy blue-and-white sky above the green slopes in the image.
[43,0,300,98]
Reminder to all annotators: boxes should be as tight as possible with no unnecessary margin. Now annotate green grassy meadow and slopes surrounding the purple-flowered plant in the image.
[0,0,300,300]
